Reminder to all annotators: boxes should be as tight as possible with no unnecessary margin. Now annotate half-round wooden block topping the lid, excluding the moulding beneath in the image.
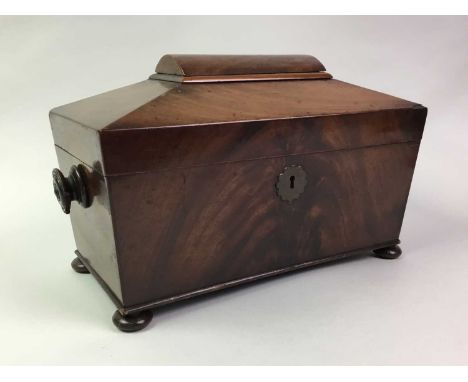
[156,54,325,76]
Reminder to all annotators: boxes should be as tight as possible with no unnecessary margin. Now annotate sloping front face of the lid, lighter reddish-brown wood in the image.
[105,80,422,134]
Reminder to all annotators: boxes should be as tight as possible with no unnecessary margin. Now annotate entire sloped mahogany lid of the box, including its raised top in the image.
[50,55,426,176]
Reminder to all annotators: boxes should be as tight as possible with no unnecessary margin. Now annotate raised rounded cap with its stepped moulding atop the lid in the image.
[150,54,332,82]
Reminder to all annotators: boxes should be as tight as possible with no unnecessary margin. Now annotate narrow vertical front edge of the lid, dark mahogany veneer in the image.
[101,107,426,175]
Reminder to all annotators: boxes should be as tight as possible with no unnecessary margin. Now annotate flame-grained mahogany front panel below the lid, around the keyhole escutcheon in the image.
[109,143,418,307]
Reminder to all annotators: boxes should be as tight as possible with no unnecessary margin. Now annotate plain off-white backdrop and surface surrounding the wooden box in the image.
[0,17,468,365]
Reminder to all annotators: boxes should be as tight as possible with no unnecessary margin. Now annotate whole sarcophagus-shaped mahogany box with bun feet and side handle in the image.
[50,55,427,331]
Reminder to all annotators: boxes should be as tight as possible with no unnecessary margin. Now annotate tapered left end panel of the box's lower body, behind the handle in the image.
[55,146,122,301]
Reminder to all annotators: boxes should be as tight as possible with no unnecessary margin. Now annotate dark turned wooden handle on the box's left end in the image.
[52,165,91,214]
